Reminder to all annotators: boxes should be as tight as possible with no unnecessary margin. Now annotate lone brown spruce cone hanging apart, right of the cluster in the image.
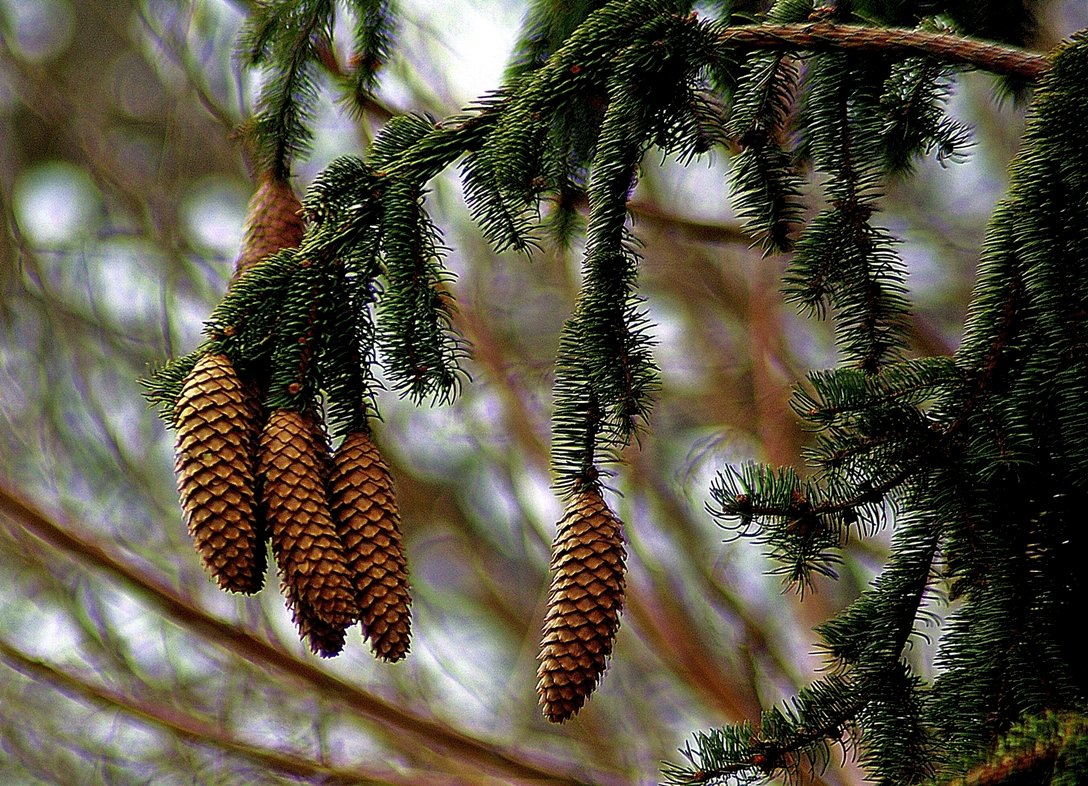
[536,488,627,723]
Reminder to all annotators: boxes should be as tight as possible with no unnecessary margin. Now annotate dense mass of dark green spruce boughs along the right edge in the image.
[676,30,1088,784]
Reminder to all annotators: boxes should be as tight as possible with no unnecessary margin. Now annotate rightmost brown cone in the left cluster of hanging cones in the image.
[329,431,411,661]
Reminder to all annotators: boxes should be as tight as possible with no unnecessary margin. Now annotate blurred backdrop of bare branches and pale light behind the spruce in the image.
[0,0,1088,786]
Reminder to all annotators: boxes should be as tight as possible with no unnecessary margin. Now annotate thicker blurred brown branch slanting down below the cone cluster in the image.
[0,482,619,784]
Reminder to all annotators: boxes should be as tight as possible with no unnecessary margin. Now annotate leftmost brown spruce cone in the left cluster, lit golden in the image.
[175,355,265,593]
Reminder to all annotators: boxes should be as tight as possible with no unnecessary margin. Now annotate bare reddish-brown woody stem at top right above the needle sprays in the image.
[718,22,1050,82]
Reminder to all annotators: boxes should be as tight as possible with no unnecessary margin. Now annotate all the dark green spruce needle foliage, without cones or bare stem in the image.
[149,0,1088,786]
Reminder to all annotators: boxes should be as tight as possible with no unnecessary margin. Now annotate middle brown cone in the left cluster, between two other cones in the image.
[259,409,358,628]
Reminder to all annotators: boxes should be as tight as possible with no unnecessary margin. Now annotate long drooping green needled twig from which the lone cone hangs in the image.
[552,6,726,492]
